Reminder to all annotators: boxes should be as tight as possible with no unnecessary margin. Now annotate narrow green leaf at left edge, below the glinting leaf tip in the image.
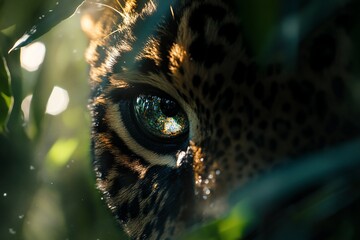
[0,55,13,133]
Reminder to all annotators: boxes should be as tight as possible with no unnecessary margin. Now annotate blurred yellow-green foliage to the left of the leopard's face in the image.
[0,0,124,240]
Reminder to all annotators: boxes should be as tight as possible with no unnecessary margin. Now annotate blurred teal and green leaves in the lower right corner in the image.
[182,139,360,240]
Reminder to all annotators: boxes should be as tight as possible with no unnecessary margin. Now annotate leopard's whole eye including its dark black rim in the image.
[114,85,191,155]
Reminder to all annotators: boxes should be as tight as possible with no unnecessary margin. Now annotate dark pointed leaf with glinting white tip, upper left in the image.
[9,0,84,52]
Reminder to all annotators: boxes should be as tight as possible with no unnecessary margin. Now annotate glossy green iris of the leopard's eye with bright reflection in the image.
[134,95,189,138]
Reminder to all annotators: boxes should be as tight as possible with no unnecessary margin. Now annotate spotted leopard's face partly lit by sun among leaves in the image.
[84,0,357,239]
